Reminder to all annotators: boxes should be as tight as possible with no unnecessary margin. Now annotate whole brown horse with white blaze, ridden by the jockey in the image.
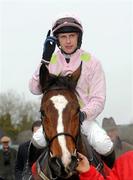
[31,64,103,180]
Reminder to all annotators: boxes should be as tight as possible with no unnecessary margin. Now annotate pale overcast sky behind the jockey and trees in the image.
[0,0,133,124]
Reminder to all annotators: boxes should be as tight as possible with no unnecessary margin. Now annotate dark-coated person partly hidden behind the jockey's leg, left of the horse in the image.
[15,120,41,180]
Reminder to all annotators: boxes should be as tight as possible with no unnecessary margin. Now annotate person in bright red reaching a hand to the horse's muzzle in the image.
[77,151,133,180]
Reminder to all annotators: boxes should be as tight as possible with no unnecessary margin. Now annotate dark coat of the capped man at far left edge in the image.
[0,148,17,180]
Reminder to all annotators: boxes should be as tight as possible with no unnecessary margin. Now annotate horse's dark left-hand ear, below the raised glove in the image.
[39,63,49,92]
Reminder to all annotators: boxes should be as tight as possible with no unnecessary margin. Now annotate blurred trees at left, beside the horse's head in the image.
[0,91,40,138]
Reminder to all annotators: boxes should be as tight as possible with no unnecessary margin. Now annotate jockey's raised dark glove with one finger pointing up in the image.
[42,30,56,63]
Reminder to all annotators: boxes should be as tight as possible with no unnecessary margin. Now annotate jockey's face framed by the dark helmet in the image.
[58,32,78,54]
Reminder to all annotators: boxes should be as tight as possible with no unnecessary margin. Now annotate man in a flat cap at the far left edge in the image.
[0,136,17,180]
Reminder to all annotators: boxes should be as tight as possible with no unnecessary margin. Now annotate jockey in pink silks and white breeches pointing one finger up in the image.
[29,15,114,166]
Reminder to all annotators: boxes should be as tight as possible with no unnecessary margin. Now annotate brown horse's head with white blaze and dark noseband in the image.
[40,63,81,178]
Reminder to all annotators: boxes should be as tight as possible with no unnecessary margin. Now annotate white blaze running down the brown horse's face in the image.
[51,95,71,167]
